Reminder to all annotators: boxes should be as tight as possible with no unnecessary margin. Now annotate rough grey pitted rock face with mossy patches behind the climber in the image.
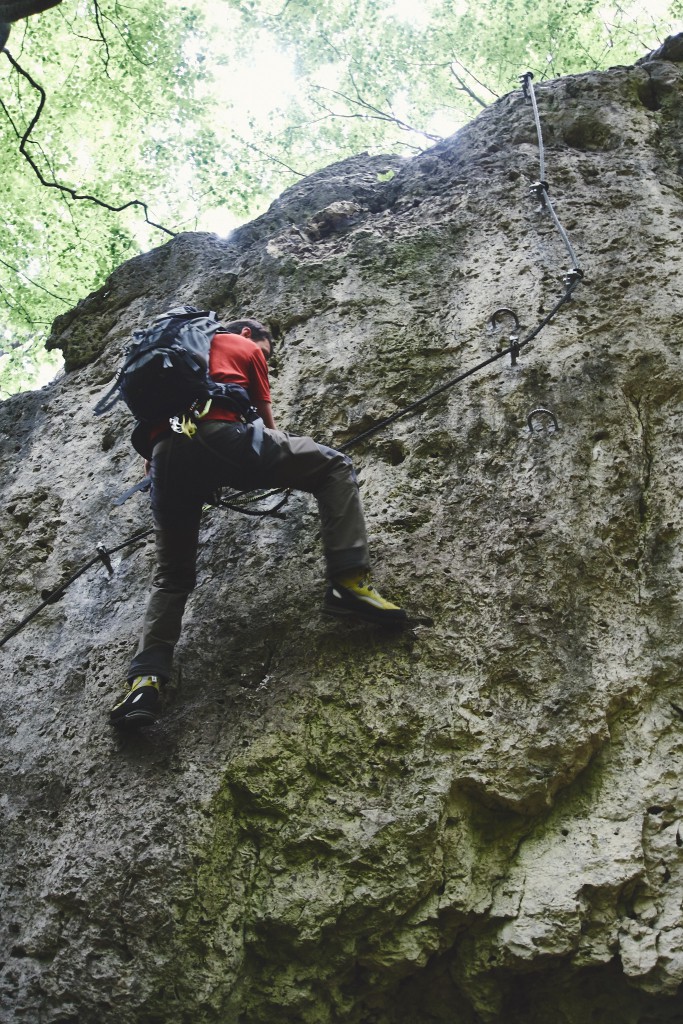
[0,32,683,1024]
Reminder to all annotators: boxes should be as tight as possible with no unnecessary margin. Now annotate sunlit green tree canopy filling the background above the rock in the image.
[0,0,683,392]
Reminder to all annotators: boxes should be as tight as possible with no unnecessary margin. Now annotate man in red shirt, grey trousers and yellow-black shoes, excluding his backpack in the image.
[110,318,405,726]
